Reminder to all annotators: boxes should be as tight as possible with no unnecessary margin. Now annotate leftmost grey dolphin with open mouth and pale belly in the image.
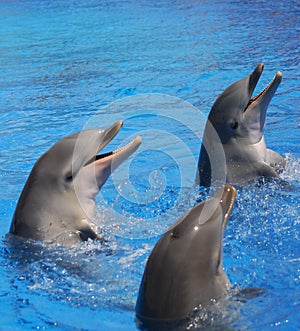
[10,121,141,246]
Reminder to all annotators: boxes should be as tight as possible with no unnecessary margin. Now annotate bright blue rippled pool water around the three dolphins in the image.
[0,0,300,331]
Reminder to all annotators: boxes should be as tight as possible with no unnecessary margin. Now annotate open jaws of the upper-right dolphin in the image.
[244,64,282,112]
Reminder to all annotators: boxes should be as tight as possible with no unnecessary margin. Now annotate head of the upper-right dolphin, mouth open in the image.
[208,63,282,144]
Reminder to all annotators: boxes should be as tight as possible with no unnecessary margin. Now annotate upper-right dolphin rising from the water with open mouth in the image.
[196,64,285,186]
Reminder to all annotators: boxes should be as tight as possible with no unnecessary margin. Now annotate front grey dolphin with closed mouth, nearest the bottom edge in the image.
[136,185,236,330]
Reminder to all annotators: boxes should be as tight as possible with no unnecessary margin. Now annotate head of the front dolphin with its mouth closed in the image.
[164,185,236,275]
